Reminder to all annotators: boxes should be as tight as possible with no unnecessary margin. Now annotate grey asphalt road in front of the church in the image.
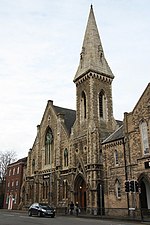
[0,210,141,225]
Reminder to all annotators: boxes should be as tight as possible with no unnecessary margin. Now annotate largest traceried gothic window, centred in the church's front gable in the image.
[45,127,53,165]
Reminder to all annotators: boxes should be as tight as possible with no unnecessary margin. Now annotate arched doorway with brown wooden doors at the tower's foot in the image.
[74,175,86,210]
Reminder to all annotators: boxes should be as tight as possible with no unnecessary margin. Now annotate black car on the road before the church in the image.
[28,203,55,218]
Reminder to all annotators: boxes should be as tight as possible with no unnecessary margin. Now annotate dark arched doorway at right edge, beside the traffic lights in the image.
[139,177,150,209]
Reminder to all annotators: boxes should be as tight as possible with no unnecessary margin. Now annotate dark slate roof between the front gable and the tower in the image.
[54,106,76,134]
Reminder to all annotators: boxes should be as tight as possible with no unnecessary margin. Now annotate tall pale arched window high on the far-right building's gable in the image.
[140,121,150,155]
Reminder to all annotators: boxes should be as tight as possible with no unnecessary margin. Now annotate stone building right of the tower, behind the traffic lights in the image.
[102,83,150,218]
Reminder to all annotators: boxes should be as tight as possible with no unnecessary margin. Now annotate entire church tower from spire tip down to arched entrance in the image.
[72,5,116,208]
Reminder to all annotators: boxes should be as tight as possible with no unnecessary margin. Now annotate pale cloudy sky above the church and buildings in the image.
[0,0,150,159]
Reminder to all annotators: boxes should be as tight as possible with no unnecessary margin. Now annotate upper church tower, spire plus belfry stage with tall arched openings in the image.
[74,6,114,138]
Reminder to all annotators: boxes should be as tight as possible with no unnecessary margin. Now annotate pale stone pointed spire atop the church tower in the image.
[74,5,114,82]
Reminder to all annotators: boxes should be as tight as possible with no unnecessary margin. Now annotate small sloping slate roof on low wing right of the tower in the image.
[102,125,124,144]
